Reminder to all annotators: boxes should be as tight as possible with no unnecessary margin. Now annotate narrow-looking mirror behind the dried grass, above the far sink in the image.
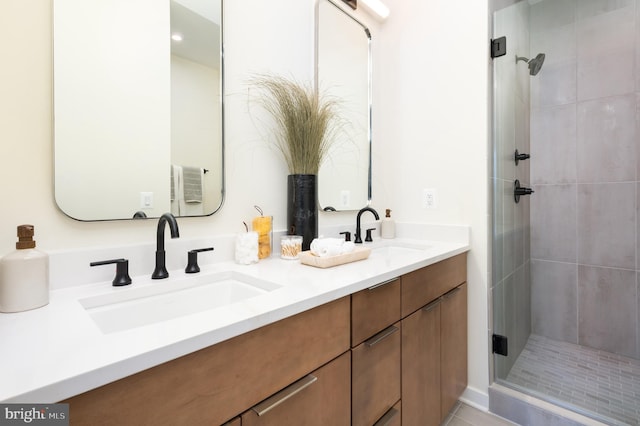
[316,0,371,211]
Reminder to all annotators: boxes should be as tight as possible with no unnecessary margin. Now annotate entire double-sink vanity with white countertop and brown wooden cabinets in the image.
[0,224,469,425]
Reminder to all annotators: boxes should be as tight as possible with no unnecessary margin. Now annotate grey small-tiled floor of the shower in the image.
[506,334,640,426]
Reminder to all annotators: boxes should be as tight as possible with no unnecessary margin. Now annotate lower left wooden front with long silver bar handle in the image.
[242,352,351,426]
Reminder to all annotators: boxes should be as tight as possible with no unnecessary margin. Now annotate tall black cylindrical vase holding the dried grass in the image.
[287,174,318,250]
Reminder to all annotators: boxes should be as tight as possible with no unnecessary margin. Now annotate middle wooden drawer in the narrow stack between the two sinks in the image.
[351,322,401,426]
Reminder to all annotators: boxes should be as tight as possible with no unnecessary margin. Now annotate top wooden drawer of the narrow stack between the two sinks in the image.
[351,278,400,347]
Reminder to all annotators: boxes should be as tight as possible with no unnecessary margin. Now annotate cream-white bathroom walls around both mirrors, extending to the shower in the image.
[0,0,489,403]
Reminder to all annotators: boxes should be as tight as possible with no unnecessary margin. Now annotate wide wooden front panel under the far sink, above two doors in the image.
[402,253,467,318]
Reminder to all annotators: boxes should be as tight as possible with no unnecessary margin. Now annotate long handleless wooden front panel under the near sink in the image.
[64,297,351,425]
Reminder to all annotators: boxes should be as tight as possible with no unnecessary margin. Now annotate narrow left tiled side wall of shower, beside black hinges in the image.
[491,1,531,379]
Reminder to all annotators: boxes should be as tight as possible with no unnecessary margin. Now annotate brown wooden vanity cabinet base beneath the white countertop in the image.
[62,254,467,426]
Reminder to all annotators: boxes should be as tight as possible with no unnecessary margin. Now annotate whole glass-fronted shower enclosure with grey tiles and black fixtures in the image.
[490,0,640,425]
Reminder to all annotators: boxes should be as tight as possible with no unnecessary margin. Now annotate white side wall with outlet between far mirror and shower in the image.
[373,0,489,404]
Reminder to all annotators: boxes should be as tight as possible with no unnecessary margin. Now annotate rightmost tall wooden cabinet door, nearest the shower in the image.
[440,283,467,418]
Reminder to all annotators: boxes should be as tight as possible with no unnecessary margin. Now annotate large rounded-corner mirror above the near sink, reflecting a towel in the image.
[53,0,224,221]
